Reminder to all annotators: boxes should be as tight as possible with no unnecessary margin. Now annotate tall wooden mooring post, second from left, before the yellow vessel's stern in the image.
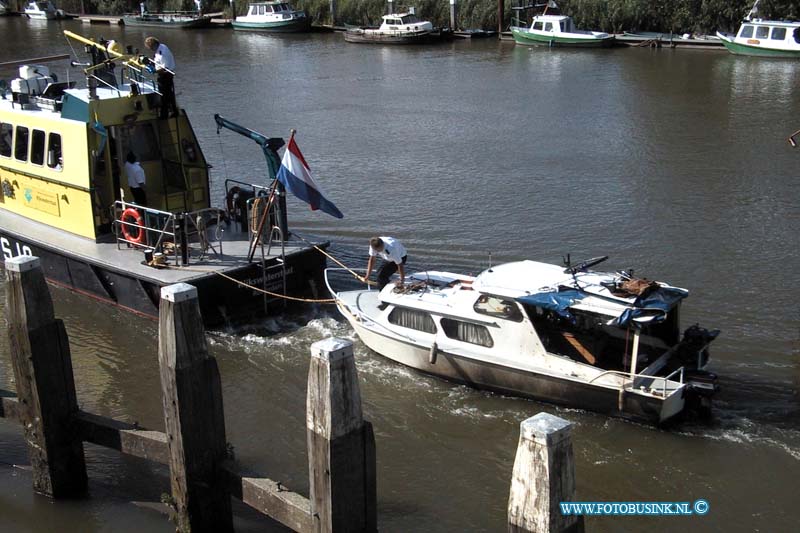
[158,283,233,533]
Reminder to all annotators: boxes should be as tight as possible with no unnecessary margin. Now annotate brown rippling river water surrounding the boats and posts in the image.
[0,19,800,532]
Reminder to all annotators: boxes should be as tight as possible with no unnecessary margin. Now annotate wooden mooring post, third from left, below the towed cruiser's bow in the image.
[306,338,378,532]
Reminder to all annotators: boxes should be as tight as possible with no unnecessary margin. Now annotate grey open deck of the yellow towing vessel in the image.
[0,209,325,285]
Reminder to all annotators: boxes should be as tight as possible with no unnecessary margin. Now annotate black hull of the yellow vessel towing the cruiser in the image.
[0,229,327,326]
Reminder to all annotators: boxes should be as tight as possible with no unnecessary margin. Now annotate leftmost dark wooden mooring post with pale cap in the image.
[6,256,87,498]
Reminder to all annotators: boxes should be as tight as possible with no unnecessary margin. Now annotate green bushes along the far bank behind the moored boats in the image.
[32,0,800,34]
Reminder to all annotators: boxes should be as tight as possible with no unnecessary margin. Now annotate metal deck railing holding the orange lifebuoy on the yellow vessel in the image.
[113,201,224,266]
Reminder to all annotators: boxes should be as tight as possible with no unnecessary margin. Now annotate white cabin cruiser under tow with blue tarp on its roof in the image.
[326,258,718,423]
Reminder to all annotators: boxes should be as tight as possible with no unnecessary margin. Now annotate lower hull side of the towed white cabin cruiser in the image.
[345,314,686,424]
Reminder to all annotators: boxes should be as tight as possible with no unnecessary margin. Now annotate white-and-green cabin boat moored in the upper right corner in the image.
[717,1,800,58]
